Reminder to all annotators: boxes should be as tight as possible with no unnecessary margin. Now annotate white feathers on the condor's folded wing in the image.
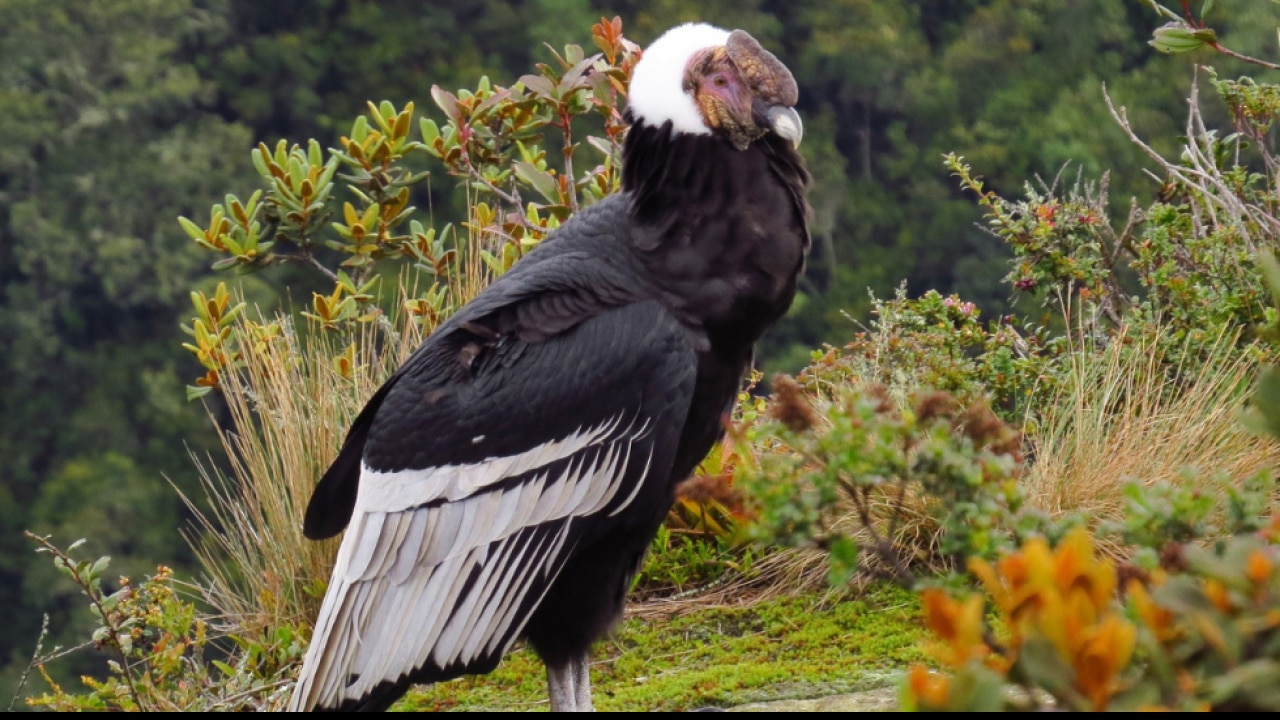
[289,415,652,710]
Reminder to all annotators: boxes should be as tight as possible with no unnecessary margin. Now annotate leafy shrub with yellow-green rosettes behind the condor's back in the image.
[179,18,637,397]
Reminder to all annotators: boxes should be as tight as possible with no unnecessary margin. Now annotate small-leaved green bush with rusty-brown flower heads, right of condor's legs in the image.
[739,377,1039,587]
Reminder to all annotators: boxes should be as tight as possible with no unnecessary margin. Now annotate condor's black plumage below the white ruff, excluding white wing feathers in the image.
[291,50,809,710]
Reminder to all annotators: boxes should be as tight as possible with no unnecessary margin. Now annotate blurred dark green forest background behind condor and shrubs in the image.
[0,0,1280,688]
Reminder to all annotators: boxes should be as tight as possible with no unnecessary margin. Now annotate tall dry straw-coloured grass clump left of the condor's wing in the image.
[183,231,503,637]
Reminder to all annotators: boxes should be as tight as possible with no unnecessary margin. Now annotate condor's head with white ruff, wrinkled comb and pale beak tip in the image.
[630,23,804,150]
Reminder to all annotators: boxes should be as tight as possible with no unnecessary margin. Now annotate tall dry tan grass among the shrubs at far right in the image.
[1023,327,1276,520]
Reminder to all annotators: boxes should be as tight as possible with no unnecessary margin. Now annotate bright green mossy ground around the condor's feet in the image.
[396,585,923,711]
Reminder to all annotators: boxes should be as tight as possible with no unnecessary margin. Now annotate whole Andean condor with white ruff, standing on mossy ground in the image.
[291,24,809,710]
